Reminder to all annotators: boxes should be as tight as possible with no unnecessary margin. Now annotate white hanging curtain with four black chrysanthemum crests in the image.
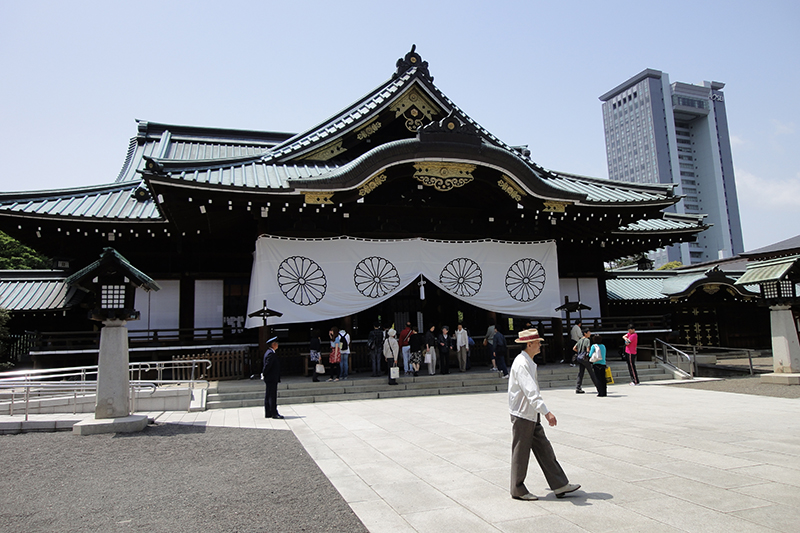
[246,235,560,328]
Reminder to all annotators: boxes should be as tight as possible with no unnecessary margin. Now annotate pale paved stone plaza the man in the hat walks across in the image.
[3,384,800,533]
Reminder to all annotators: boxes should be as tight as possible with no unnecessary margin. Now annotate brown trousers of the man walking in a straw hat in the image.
[511,415,569,496]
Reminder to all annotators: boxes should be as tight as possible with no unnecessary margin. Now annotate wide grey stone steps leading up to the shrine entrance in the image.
[206,361,673,409]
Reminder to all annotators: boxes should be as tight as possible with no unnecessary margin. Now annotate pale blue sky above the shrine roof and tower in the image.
[0,0,800,249]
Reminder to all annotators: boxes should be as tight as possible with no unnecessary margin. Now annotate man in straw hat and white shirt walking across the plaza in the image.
[508,329,581,501]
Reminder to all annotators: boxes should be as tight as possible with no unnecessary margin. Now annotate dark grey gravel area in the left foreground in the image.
[0,424,367,533]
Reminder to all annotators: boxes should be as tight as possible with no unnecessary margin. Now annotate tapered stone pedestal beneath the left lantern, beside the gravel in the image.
[94,320,130,419]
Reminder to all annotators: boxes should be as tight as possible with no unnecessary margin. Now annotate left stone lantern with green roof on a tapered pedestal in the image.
[66,248,159,435]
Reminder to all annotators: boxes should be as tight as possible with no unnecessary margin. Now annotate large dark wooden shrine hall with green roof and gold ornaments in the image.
[0,48,707,366]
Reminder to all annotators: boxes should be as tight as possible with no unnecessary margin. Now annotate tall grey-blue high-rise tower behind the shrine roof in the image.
[600,69,744,266]
